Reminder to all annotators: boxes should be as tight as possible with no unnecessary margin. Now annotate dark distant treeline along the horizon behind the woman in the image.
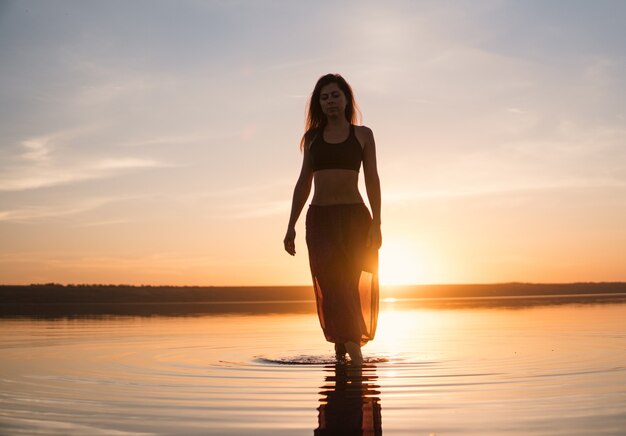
[0,282,626,305]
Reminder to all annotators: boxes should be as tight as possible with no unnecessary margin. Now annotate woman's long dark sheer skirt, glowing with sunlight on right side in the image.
[306,203,378,345]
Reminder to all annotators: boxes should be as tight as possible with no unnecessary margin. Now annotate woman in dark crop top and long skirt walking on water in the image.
[284,74,382,365]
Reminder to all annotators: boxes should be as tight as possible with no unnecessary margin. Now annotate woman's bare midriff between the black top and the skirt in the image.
[311,169,363,206]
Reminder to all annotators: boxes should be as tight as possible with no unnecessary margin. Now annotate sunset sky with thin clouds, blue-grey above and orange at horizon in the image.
[0,0,626,285]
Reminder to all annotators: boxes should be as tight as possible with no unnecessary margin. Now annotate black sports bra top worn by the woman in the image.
[309,124,363,173]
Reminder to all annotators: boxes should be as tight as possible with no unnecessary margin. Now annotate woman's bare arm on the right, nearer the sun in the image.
[363,127,382,248]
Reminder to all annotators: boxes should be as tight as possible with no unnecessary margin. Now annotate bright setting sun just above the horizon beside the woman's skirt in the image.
[378,240,424,285]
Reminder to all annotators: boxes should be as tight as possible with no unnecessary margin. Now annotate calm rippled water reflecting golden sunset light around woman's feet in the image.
[0,302,626,435]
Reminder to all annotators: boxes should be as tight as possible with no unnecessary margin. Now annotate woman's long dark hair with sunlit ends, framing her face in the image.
[300,74,361,150]
